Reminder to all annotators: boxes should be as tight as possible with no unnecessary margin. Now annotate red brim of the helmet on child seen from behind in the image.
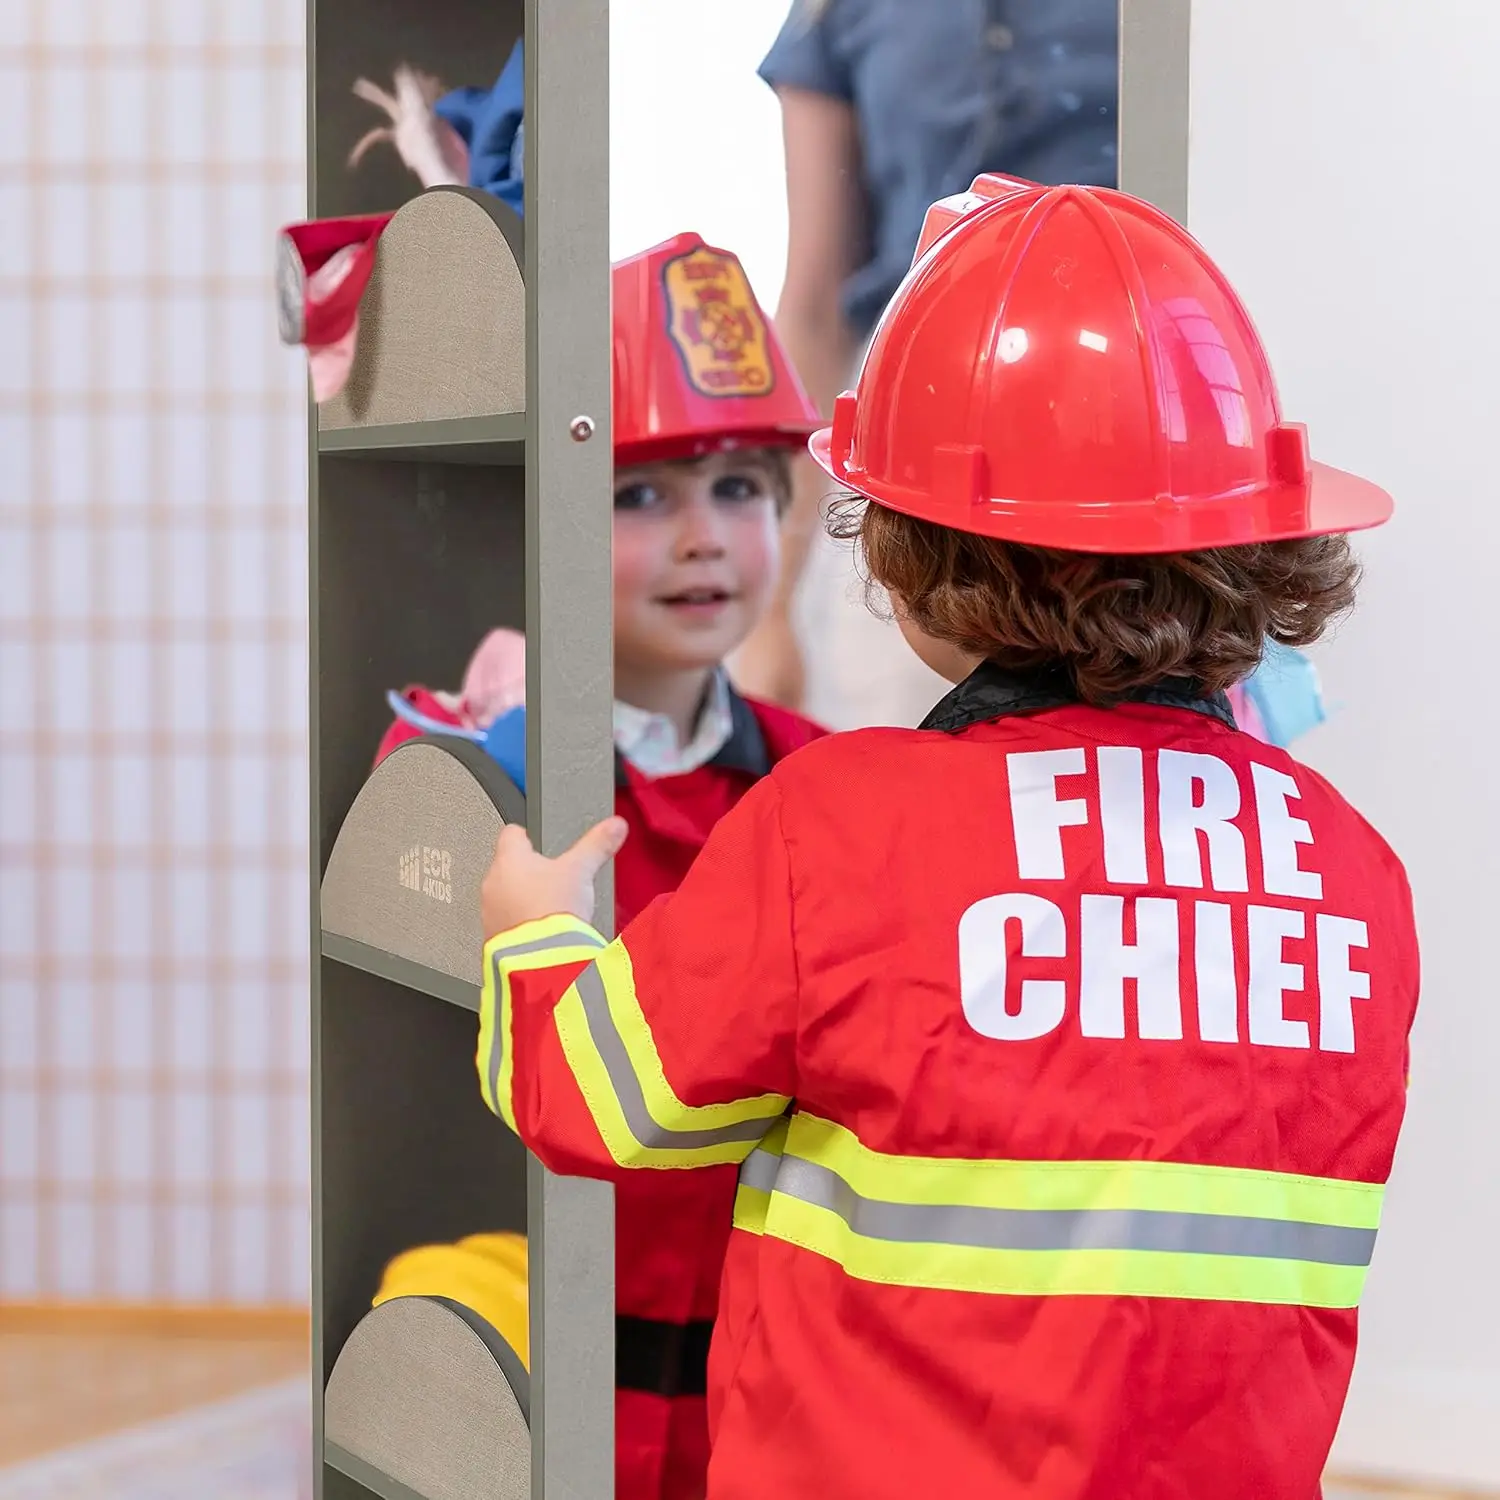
[807,428,1395,555]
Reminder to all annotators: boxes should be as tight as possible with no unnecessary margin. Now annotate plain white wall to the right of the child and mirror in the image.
[1190,0,1500,1485]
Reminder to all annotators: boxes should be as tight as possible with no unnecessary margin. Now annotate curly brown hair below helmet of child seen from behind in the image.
[828,497,1359,705]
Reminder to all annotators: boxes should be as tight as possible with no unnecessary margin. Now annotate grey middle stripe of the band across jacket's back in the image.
[776,1157,1376,1266]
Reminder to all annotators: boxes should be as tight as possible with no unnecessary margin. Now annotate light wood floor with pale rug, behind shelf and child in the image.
[0,1323,1478,1500]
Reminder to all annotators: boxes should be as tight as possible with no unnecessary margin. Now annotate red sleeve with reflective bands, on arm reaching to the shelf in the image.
[479,779,797,1178]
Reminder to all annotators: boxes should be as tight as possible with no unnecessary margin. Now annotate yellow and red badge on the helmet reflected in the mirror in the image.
[662,246,776,396]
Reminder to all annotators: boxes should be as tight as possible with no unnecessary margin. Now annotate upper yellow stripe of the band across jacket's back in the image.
[786,1115,1385,1229]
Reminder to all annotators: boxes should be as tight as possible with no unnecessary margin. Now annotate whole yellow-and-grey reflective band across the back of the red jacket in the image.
[756,1115,1383,1308]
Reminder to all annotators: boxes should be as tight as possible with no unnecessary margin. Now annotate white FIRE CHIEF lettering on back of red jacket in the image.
[959,746,1371,1053]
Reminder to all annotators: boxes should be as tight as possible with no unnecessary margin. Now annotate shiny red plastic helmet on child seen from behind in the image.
[810,176,1392,552]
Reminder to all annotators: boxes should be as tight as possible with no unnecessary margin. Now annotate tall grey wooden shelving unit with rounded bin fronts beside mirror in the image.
[308,0,614,1500]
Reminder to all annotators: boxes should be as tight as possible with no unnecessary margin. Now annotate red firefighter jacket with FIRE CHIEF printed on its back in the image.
[480,666,1418,1500]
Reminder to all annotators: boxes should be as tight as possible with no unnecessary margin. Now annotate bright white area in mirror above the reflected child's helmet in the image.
[609,0,789,312]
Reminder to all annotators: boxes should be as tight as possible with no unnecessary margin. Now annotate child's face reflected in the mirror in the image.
[614,450,780,675]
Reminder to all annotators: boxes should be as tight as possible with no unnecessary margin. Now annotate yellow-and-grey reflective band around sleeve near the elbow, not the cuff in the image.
[554,939,788,1169]
